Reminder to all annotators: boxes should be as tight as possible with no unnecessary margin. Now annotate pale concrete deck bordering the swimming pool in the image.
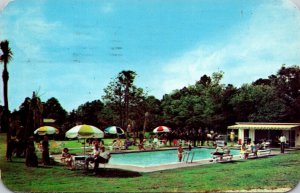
[55,147,288,173]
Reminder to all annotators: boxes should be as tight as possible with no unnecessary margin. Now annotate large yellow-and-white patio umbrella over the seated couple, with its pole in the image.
[66,125,104,154]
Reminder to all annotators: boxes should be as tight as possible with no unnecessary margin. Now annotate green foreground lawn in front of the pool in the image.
[0,134,300,192]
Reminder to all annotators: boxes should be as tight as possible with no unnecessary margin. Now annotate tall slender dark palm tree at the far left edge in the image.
[0,40,13,141]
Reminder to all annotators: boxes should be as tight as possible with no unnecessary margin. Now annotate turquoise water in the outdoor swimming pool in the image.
[109,148,240,167]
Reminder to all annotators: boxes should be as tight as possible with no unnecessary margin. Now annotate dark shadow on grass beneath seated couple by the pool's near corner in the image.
[83,168,142,178]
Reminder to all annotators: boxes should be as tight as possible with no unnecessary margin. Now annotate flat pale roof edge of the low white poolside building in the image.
[227,122,300,130]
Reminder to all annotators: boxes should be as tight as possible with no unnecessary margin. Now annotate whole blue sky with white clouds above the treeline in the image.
[0,0,300,111]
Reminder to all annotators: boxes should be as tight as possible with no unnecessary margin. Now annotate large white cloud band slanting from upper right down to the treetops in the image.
[159,1,300,93]
